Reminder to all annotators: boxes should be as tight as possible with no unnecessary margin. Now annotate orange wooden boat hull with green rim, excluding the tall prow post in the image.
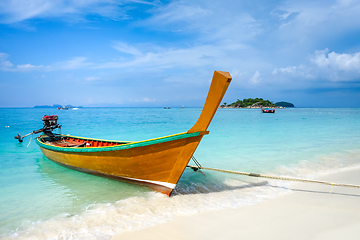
[36,132,208,196]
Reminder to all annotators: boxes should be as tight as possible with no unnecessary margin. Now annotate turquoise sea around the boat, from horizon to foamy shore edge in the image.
[0,108,360,239]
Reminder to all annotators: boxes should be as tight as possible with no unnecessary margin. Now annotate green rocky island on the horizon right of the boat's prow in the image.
[220,98,295,108]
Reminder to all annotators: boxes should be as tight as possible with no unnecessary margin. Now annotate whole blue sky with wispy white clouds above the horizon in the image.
[0,0,360,107]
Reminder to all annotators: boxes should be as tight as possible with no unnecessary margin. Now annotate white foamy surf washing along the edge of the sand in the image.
[4,151,360,239]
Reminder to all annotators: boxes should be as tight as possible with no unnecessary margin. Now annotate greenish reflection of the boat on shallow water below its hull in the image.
[37,157,151,205]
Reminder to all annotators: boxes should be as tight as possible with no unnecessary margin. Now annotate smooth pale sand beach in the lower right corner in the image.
[111,168,360,240]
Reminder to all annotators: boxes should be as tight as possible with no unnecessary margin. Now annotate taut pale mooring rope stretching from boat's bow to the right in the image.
[187,165,360,188]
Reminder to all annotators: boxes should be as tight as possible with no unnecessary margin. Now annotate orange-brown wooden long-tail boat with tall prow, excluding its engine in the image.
[36,71,232,196]
